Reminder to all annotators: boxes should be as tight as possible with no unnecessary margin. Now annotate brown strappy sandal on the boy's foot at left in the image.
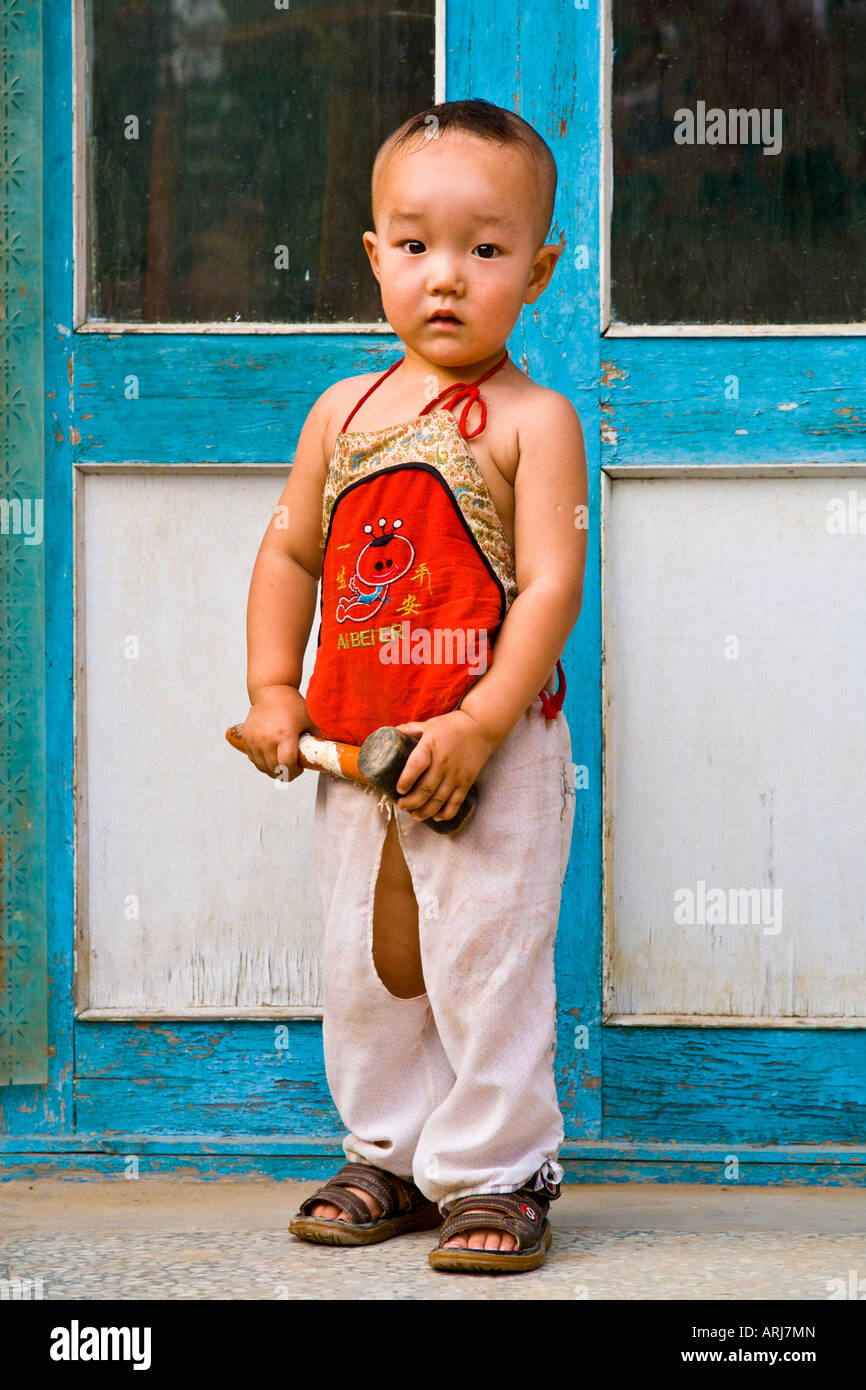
[289,1163,442,1245]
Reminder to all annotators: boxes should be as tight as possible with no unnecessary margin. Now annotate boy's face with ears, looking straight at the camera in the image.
[364,131,562,367]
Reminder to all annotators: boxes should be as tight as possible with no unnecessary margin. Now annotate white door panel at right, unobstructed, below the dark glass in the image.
[603,470,866,1022]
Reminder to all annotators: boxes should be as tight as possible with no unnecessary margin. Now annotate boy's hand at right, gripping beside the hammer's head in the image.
[396,709,496,820]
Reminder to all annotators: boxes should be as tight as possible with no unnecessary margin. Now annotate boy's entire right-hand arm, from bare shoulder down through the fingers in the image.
[398,392,588,820]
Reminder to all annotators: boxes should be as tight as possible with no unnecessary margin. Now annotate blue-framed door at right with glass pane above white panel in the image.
[592,0,866,1182]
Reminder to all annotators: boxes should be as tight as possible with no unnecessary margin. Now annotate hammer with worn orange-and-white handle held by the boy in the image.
[225,724,478,835]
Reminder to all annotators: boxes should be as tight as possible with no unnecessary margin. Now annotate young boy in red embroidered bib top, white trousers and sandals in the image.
[243,100,587,1270]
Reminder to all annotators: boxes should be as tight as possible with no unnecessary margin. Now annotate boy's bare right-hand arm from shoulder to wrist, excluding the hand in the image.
[460,395,588,746]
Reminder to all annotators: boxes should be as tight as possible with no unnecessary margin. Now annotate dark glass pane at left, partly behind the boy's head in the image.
[86,0,435,322]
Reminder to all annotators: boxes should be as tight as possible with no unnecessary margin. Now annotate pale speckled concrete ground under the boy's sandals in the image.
[0,1177,866,1300]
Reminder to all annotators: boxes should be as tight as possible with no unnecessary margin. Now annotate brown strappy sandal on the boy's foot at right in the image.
[427,1186,559,1275]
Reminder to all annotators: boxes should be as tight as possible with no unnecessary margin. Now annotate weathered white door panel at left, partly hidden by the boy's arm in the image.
[76,468,321,1016]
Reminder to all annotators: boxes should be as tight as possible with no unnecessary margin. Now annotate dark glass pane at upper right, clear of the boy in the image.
[610,0,866,324]
